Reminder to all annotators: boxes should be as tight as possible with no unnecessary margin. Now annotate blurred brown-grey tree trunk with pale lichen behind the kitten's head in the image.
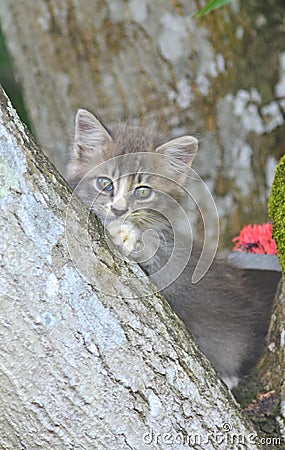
[0,0,285,246]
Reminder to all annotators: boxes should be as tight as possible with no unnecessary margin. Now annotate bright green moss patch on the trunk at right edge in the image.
[268,155,285,274]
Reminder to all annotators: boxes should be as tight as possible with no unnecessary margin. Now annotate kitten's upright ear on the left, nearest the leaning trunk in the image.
[74,109,112,158]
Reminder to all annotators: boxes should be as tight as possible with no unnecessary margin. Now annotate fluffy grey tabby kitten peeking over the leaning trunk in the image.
[67,109,274,388]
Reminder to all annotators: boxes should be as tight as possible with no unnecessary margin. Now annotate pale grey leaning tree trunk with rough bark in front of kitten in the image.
[0,91,258,450]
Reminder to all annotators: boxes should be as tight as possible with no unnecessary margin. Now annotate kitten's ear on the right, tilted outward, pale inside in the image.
[155,136,198,166]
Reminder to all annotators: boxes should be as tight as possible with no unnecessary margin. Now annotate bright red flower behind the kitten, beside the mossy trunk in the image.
[232,223,277,255]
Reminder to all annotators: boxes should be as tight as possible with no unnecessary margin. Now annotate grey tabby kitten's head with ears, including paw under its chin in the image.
[68,110,197,260]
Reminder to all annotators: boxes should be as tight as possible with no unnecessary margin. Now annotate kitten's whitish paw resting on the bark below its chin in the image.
[107,220,138,256]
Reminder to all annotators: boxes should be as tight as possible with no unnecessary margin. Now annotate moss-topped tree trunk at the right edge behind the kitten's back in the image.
[233,155,285,442]
